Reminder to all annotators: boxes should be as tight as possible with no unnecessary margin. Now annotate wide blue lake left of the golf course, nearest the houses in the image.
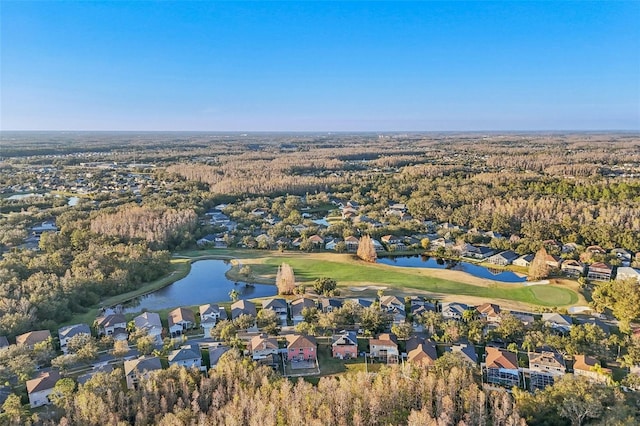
[124,260,277,313]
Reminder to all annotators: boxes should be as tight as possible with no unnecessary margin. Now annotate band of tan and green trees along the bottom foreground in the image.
[4,351,637,426]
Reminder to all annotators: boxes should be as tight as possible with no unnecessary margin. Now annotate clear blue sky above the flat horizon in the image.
[0,0,640,131]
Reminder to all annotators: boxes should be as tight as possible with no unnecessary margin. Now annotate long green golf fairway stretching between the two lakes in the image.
[251,254,578,306]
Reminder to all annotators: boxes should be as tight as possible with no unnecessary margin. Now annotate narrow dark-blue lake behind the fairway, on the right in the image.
[378,256,527,283]
